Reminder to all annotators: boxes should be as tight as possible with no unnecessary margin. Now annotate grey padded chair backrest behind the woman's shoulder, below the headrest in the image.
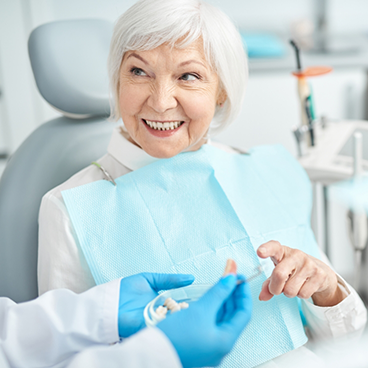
[0,117,112,302]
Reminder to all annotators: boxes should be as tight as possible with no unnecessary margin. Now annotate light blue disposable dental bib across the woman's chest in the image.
[62,145,319,367]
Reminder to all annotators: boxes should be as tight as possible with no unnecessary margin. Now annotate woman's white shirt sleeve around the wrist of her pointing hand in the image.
[302,252,367,340]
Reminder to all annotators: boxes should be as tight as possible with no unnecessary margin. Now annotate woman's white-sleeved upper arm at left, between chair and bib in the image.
[38,191,96,295]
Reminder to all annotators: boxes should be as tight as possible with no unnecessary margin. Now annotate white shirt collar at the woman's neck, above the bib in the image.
[107,126,159,171]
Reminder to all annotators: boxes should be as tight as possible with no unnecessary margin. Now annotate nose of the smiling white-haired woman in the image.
[147,83,178,113]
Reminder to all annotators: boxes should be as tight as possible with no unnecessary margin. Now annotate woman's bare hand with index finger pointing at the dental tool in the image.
[257,240,344,307]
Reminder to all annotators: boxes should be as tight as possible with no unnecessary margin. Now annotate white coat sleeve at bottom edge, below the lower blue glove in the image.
[68,328,182,368]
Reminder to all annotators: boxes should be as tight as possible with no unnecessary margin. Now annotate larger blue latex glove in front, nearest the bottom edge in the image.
[157,274,252,368]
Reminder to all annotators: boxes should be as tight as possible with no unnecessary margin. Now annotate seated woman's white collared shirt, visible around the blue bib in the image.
[38,127,367,367]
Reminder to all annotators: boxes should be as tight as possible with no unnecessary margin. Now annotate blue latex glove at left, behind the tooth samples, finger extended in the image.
[118,273,194,337]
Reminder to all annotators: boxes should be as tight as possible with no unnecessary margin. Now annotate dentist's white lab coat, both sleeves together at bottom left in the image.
[0,280,181,368]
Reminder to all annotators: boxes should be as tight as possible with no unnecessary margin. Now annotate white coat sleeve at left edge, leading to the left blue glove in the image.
[0,280,120,368]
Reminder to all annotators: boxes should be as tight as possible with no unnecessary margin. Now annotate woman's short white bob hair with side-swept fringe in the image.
[108,0,248,136]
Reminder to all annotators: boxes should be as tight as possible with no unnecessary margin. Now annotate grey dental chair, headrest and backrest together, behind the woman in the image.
[0,19,114,302]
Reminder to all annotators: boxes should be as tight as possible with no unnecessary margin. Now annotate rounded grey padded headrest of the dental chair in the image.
[28,19,113,118]
